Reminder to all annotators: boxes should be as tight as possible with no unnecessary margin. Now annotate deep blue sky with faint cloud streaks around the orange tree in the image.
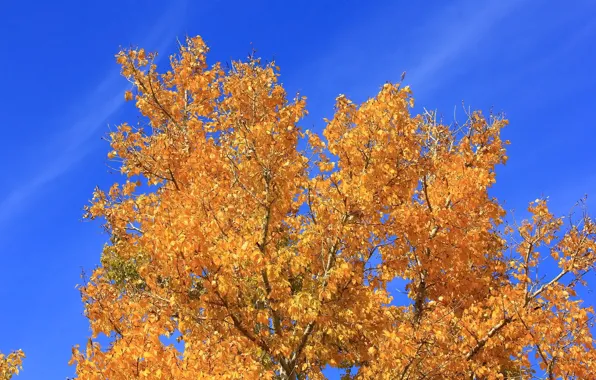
[0,0,596,379]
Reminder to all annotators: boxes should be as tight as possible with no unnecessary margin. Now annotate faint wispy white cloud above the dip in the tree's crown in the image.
[302,0,526,104]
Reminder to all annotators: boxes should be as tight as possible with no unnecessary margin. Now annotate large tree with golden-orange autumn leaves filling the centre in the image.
[72,37,596,379]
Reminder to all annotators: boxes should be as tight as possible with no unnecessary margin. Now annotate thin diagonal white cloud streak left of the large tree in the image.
[0,0,186,224]
